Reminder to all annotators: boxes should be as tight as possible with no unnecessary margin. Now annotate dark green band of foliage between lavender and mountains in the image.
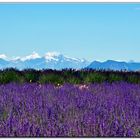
[0,69,140,85]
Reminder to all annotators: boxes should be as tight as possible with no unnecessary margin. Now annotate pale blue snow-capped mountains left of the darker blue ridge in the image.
[0,52,89,70]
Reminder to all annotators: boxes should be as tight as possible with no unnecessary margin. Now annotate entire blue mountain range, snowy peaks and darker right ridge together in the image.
[0,52,140,71]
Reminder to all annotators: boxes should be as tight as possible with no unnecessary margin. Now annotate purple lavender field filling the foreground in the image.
[0,82,140,137]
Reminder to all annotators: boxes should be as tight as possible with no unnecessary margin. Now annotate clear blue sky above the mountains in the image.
[0,3,140,61]
